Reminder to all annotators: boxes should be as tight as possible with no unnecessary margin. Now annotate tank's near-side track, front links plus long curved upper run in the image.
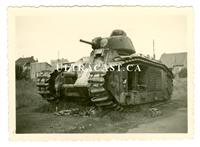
[88,56,173,111]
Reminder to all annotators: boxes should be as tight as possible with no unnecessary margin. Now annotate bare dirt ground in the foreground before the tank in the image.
[16,98,187,133]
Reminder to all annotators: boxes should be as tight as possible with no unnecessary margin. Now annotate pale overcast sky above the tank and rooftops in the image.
[15,8,187,62]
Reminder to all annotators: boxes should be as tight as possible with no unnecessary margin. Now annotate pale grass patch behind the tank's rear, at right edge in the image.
[172,77,187,98]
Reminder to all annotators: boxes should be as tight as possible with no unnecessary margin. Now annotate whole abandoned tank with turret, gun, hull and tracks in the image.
[37,30,173,110]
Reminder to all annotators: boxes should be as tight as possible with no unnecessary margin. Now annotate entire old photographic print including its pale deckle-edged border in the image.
[8,7,193,140]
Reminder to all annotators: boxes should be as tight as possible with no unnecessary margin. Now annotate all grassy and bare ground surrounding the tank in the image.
[16,78,187,133]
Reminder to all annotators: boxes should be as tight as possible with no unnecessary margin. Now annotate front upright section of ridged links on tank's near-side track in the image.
[88,71,123,111]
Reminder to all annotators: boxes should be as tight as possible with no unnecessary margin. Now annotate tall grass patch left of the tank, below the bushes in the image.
[16,80,47,109]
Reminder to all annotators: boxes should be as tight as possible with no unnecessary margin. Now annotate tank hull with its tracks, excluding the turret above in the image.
[38,54,173,110]
